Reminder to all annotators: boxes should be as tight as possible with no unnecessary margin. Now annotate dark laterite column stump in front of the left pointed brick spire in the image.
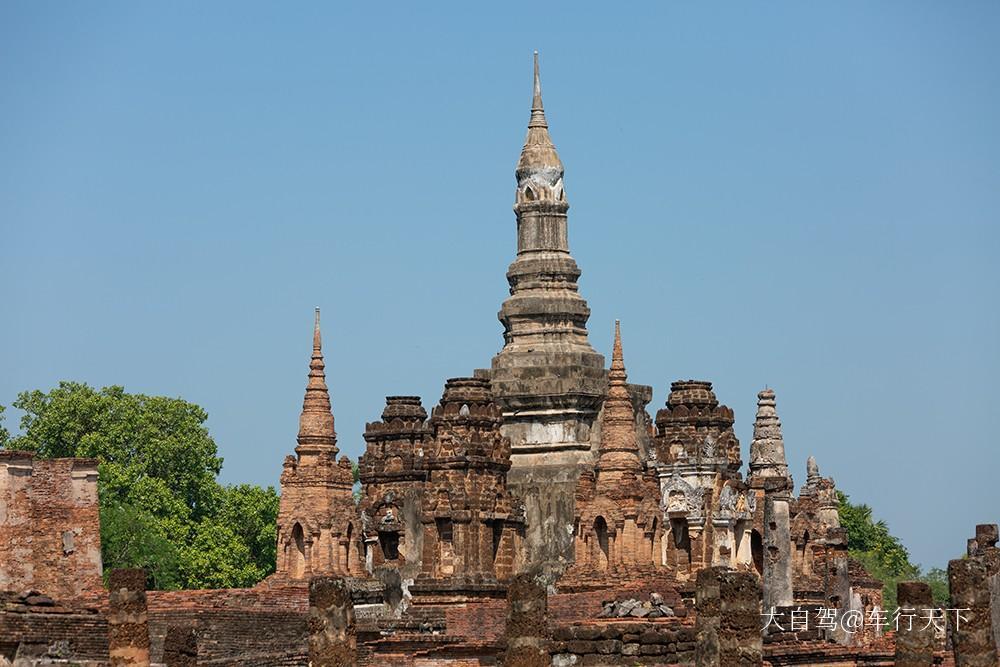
[309,577,357,667]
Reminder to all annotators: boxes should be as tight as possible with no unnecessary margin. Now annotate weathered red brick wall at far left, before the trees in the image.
[0,451,102,601]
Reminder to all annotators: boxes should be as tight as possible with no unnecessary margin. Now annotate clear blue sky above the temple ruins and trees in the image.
[0,2,1000,566]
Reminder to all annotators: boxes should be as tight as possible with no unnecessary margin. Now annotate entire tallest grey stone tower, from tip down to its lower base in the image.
[490,55,607,563]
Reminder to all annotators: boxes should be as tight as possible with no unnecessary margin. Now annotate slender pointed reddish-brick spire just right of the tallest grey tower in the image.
[597,320,642,485]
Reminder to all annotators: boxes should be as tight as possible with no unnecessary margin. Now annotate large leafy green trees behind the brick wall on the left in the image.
[0,382,278,589]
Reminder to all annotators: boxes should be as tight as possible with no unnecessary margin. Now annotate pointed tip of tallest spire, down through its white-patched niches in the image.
[516,51,566,204]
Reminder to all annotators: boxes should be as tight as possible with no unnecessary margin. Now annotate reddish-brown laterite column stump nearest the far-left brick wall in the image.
[108,569,149,667]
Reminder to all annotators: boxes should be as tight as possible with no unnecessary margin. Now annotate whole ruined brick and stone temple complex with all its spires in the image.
[0,55,1000,667]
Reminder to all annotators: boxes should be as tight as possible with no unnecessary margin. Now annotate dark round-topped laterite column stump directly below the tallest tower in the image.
[502,573,552,667]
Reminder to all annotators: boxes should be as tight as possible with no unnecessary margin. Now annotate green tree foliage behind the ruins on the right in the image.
[837,491,948,610]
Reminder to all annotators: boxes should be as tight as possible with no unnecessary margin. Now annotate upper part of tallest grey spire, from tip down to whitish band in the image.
[491,53,606,448]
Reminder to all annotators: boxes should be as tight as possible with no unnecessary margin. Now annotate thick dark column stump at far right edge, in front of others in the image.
[948,557,1000,667]
